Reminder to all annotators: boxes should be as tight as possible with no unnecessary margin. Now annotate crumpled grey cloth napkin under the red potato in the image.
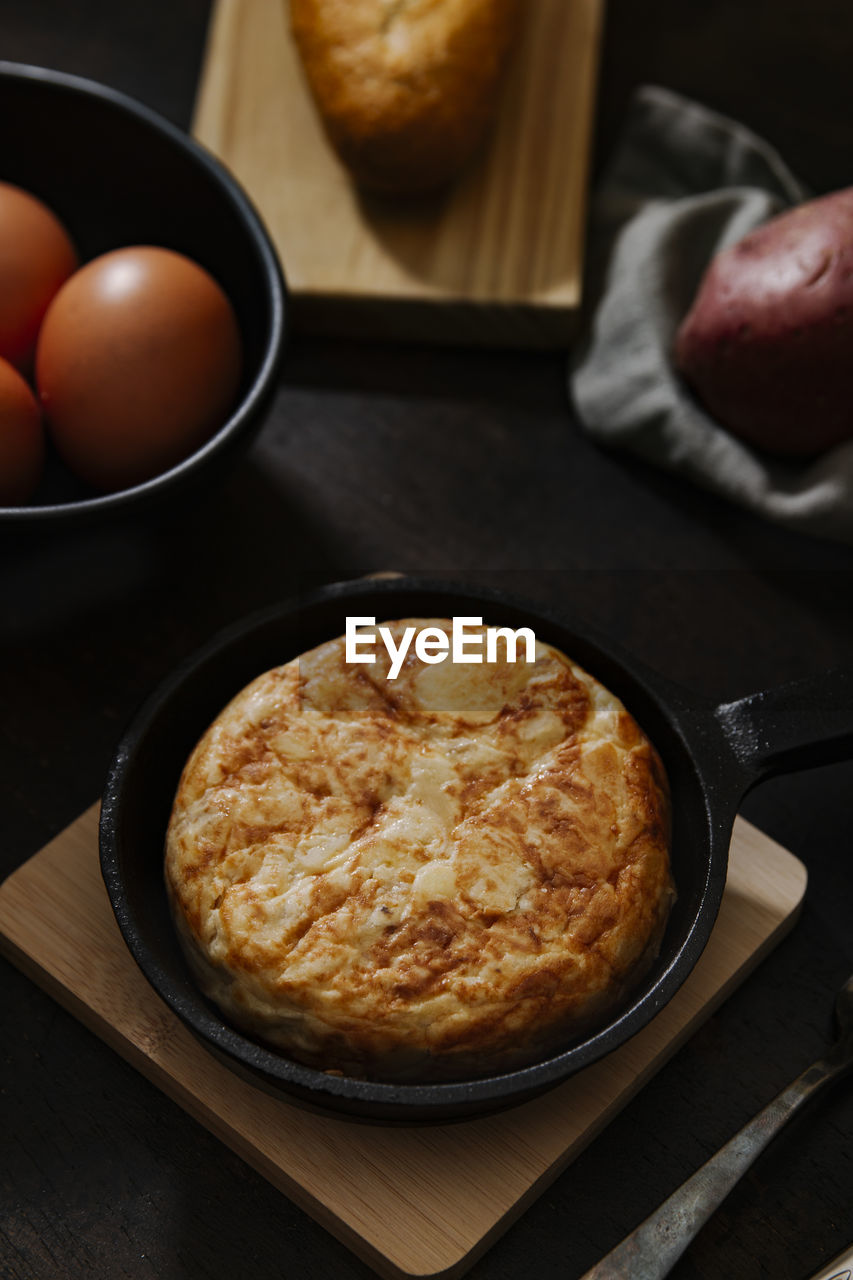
[570,87,853,541]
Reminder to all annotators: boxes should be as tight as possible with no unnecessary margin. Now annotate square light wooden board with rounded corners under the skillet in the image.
[0,808,806,1280]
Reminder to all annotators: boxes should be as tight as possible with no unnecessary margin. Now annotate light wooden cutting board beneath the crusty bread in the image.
[193,0,603,347]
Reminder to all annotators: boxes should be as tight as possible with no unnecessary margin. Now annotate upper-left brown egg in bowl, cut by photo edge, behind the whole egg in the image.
[0,182,77,374]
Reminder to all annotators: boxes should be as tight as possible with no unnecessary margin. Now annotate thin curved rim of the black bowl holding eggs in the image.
[0,59,287,525]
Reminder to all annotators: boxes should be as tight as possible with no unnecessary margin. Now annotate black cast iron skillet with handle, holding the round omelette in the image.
[100,579,853,1123]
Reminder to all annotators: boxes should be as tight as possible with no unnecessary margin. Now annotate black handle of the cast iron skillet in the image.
[716,671,853,782]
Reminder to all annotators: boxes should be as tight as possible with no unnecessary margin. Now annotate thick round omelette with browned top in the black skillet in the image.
[165,618,674,1080]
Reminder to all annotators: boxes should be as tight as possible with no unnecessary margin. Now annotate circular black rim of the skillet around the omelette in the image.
[99,576,727,1123]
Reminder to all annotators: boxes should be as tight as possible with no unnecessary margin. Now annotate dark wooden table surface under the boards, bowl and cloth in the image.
[0,0,853,1280]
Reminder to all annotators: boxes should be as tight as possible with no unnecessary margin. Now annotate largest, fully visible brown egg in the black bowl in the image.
[36,246,242,490]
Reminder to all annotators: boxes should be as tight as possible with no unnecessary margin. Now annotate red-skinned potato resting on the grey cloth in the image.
[675,187,853,457]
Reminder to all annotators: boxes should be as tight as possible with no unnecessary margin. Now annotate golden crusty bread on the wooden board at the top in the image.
[291,0,521,192]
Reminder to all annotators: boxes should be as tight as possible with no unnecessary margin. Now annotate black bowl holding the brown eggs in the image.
[0,61,287,526]
